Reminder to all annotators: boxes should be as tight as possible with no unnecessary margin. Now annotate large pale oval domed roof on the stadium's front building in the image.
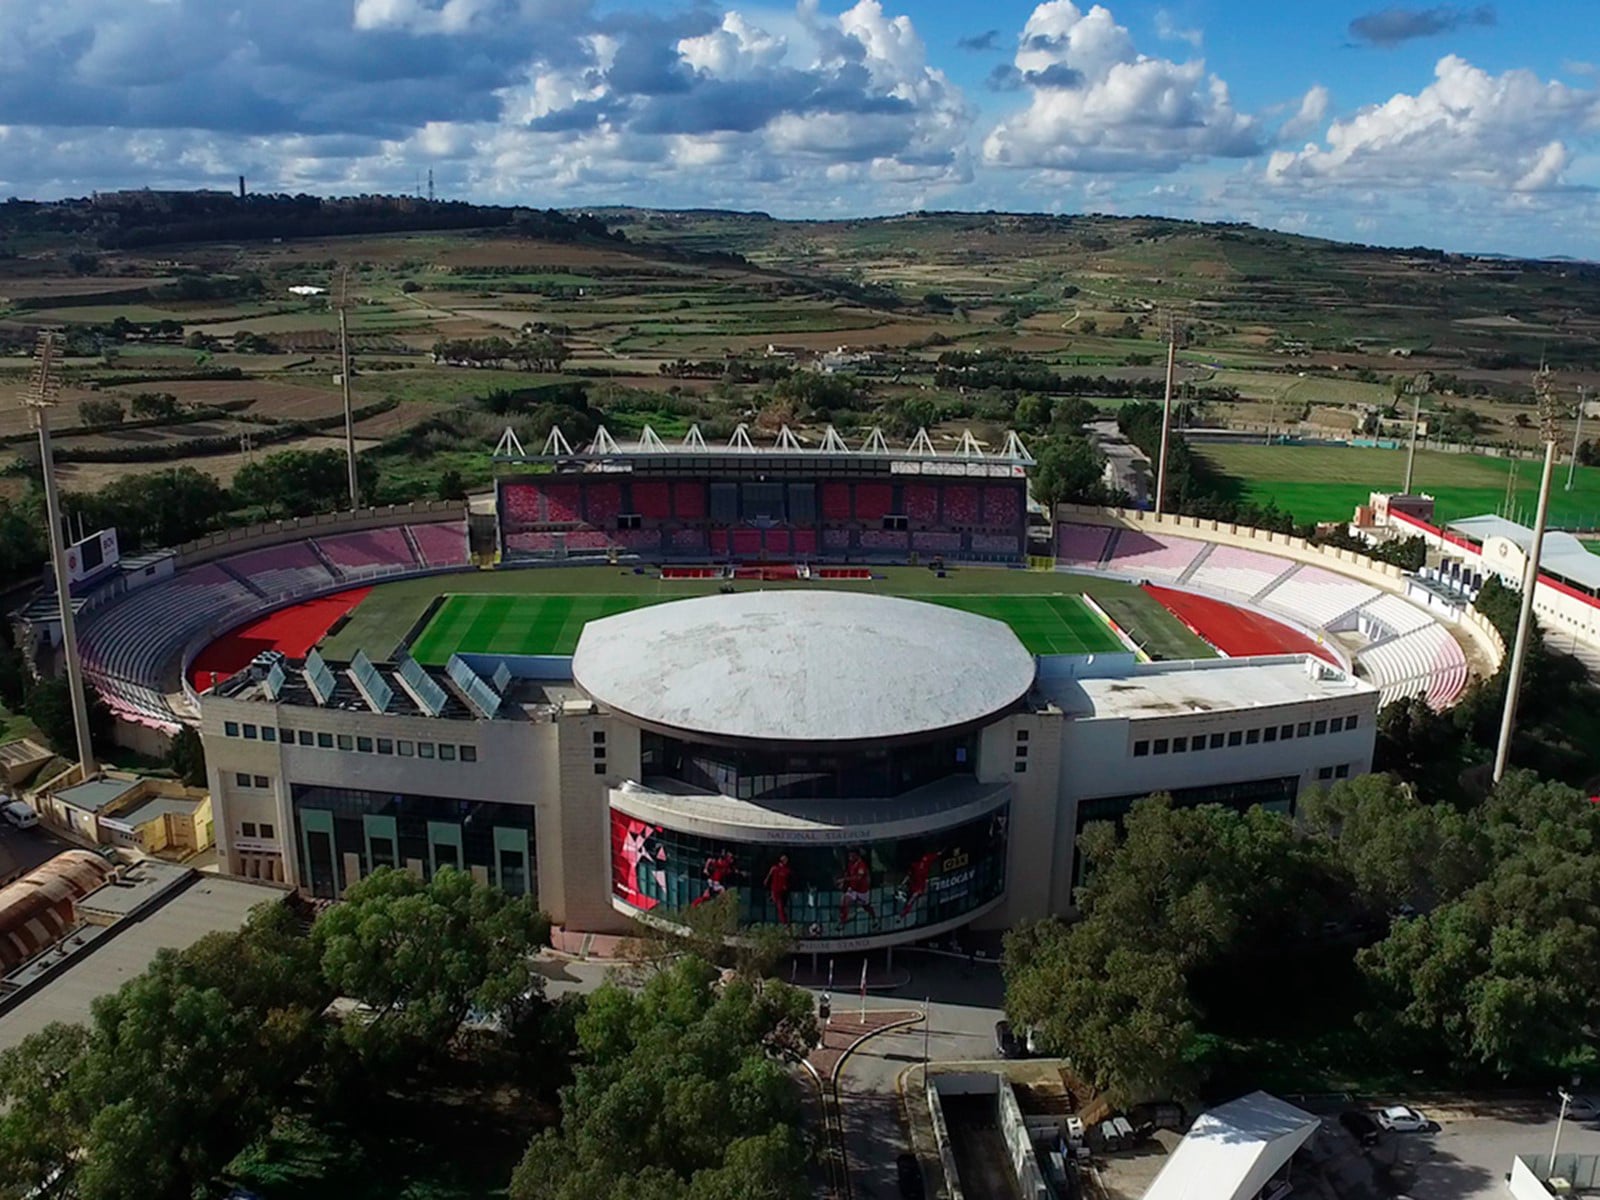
[573,590,1034,742]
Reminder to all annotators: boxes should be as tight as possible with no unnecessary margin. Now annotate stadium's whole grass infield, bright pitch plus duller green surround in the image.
[322,566,1214,662]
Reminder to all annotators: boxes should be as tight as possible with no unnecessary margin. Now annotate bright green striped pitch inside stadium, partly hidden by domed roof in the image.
[411,594,1123,664]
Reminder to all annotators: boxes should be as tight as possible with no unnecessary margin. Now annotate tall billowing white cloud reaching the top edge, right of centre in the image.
[984,0,1261,171]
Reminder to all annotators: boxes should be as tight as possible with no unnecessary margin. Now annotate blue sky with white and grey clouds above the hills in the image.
[0,0,1600,259]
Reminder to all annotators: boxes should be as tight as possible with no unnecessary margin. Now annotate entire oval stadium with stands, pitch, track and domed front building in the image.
[22,429,1504,949]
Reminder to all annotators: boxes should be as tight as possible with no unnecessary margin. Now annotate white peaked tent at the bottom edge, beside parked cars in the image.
[1144,1091,1317,1200]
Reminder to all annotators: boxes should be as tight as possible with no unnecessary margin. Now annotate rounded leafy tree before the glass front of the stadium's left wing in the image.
[312,867,550,1069]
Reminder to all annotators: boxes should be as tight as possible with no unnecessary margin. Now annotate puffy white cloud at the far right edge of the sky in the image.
[1266,54,1600,192]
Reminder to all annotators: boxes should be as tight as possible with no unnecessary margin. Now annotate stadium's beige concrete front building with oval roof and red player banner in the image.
[200,590,1378,949]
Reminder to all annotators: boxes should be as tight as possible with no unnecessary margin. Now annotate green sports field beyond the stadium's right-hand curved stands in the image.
[1195,445,1600,530]
